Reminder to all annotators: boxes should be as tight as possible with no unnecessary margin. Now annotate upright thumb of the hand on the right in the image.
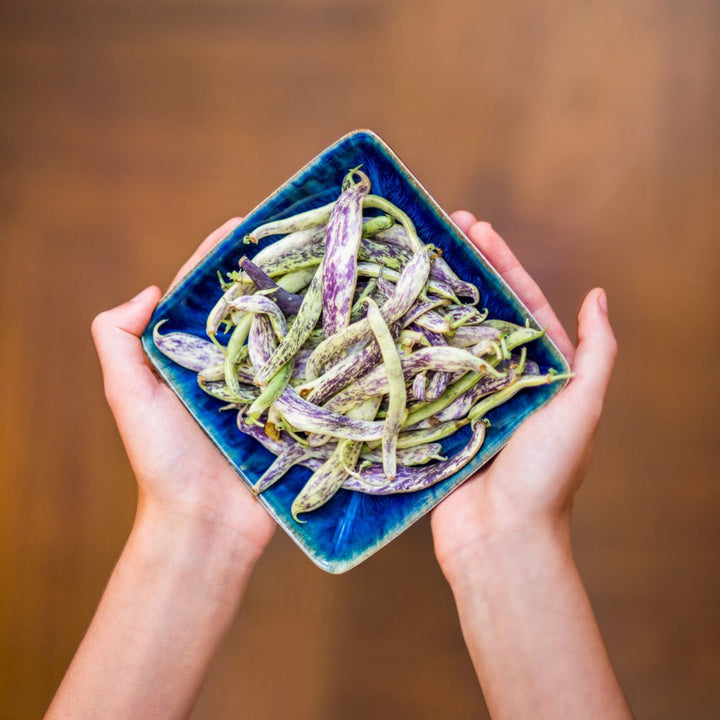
[558,288,617,422]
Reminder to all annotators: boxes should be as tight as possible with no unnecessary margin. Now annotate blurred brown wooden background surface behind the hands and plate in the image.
[0,0,720,720]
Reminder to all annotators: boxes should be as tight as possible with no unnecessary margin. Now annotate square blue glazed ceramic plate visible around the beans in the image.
[142,130,569,573]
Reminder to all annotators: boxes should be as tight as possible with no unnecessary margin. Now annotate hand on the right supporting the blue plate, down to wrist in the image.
[432,211,617,574]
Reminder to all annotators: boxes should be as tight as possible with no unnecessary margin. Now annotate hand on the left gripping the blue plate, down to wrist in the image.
[92,218,275,558]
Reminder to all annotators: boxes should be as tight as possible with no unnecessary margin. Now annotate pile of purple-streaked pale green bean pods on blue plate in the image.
[154,168,565,521]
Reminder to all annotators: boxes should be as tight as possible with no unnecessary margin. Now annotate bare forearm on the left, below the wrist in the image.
[47,500,256,719]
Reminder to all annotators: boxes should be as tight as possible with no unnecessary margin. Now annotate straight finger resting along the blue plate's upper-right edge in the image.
[467,219,575,362]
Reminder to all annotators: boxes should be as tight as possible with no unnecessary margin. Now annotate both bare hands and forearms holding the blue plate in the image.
[46,211,631,719]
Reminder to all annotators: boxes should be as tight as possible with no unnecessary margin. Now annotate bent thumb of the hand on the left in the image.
[91,286,160,413]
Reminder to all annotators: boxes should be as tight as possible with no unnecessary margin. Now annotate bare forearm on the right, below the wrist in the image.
[445,528,632,720]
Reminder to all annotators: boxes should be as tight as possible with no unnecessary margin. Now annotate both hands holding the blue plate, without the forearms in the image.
[92,211,617,576]
